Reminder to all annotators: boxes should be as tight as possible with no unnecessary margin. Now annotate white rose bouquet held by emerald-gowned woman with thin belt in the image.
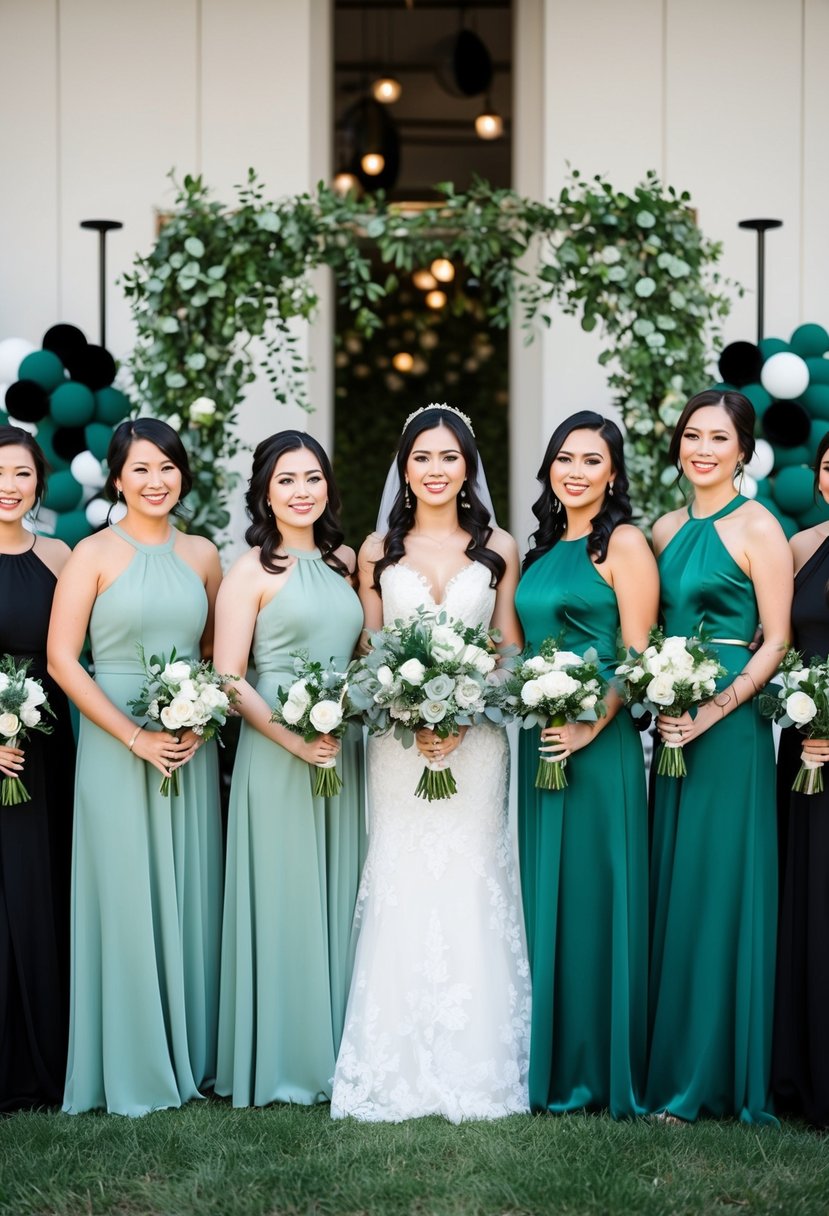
[614,627,726,777]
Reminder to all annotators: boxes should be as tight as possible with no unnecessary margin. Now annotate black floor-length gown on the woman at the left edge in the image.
[0,541,75,1110]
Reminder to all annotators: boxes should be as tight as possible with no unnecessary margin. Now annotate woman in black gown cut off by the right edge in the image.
[772,433,829,1127]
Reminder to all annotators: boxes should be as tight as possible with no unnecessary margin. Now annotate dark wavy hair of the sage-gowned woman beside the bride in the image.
[244,430,349,578]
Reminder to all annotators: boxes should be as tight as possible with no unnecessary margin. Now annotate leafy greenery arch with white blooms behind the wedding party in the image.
[125,170,729,537]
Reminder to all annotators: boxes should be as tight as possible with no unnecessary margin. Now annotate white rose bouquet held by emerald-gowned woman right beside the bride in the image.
[504,637,608,789]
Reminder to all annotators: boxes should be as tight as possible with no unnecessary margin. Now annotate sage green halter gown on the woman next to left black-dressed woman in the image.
[63,527,221,1115]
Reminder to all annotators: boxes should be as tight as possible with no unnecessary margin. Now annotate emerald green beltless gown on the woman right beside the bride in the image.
[515,537,648,1118]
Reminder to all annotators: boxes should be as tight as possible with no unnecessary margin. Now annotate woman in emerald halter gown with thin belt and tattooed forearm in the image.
[647,389,791,1124]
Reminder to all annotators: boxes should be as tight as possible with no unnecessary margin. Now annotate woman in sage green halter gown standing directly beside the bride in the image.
[216,430,363,1107]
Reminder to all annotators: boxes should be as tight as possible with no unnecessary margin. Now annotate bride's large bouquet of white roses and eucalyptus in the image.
[350,609,504,801]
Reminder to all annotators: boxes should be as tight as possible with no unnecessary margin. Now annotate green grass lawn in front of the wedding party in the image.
[0,1099,829,1216]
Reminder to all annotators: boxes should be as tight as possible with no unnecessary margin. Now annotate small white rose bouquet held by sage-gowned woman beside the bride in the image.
[271,651,359,798]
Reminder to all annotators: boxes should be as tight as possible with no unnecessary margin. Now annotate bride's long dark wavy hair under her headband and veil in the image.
[372,405,507,592]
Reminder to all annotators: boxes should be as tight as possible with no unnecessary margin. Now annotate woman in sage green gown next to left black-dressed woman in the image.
[49,418,221,1115]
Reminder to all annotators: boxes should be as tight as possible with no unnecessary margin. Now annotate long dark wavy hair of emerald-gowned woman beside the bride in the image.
[521,410,633,570]
